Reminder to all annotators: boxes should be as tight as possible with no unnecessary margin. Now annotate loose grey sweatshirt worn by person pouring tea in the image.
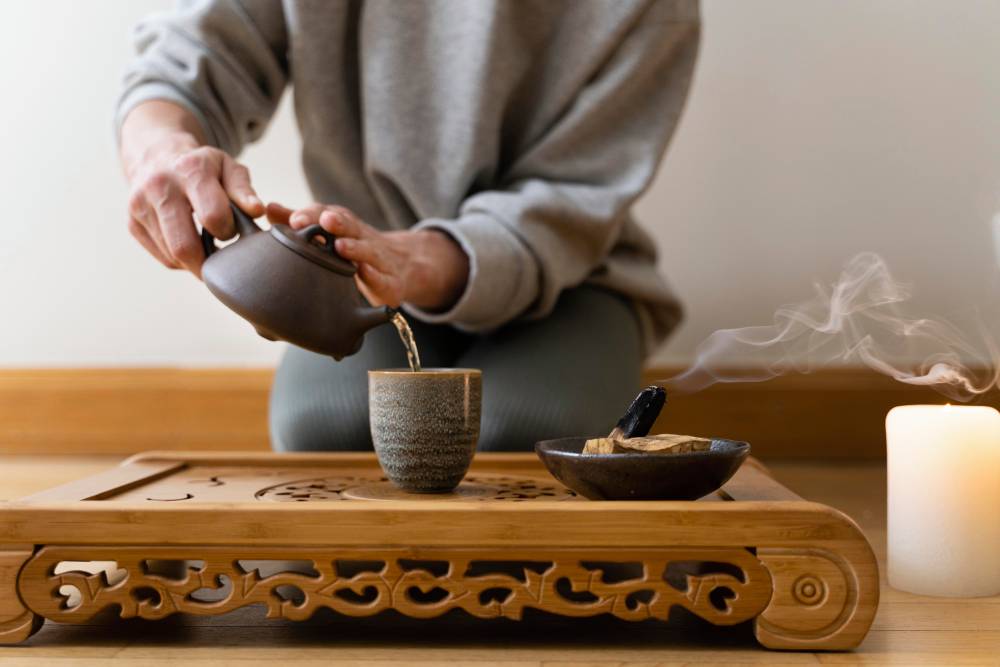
[117,0,699,350]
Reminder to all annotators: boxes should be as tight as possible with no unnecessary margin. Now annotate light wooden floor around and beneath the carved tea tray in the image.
[0,456,1000,667]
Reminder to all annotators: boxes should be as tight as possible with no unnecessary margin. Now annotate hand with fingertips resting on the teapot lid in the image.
[267,203,469,311]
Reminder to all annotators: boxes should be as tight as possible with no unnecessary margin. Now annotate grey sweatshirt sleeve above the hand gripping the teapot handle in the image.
[115,0,288,155]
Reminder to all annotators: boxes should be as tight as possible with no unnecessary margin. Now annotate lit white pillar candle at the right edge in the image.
[885,405,1000,597]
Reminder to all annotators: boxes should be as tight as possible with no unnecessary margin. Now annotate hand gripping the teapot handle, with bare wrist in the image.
[122,100,264,277]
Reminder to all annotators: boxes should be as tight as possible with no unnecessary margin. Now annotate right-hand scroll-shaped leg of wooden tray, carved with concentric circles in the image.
[754,543,879,650]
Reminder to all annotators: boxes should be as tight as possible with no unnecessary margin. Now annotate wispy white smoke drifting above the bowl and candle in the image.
[663,252,1000,401]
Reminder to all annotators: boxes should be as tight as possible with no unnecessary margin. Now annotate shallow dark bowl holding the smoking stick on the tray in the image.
[535,438,750,500]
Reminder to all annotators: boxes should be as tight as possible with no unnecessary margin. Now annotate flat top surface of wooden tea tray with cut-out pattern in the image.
[20,452,756,506]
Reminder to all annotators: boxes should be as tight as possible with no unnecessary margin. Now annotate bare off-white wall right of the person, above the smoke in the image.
[640,0,1000,363]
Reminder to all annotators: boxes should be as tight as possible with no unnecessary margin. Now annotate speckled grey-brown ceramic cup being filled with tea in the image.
[368,368,483,493]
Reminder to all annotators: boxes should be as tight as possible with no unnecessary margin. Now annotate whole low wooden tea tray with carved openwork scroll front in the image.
[0,452,878,650]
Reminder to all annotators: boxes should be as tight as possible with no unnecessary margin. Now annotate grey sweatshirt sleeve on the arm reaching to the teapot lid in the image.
[405,2,699,332]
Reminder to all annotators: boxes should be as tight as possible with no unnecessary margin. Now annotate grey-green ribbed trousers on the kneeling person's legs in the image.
[270,287,642,451]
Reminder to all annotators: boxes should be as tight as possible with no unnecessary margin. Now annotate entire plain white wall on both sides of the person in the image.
[0,0,1000,366]
